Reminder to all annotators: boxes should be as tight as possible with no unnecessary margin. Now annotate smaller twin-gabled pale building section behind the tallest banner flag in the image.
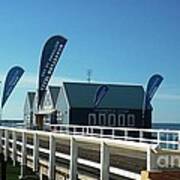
[24,86,60,127]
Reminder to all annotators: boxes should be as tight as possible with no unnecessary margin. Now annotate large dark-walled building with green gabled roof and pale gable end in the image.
[57,82,152,128]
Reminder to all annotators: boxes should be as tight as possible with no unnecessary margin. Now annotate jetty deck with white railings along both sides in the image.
[0,125,180,180]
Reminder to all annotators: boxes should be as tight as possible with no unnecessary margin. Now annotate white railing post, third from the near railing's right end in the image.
[69,137,78,180]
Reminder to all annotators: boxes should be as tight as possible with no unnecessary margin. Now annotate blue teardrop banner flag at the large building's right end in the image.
[143,74,164,114]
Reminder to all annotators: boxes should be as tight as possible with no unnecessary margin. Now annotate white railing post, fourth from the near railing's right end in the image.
[48,135,56,180]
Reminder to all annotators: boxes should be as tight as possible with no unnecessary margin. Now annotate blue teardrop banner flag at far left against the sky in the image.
[1,66,24,108]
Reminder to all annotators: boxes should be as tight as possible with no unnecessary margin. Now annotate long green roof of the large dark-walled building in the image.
[63,82,144,109]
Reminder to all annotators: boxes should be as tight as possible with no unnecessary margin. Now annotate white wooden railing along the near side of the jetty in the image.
[0,126,160,180]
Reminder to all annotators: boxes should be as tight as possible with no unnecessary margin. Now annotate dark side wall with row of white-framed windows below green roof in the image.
[70,108,151,128]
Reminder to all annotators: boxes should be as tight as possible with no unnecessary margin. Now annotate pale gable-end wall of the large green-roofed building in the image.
[56,89,69,124]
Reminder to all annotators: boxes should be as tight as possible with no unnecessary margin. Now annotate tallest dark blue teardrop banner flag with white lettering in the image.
[37,35,67,108]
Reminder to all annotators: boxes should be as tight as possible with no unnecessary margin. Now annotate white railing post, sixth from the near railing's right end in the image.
[20,132,27,179]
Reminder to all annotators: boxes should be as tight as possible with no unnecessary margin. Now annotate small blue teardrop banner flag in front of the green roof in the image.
[94,85,109,108]
